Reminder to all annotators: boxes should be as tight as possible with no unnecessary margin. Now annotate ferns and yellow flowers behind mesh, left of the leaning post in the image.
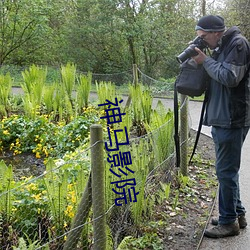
[0,144,90,249]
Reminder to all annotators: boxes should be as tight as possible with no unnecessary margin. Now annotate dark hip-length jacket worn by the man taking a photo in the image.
[203,27,250,128]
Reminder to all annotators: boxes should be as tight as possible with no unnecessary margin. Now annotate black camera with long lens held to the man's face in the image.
[176,36,208,63]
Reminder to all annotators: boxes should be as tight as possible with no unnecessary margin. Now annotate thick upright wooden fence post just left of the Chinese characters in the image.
[90,124,106,250]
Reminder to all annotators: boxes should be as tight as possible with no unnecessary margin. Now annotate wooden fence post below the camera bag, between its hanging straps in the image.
[180,94,188,176]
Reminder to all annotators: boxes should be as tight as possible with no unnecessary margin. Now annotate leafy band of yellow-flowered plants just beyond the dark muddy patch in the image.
[0,111,99,158]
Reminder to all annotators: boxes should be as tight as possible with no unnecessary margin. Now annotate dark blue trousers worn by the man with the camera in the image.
[212,127,249,224]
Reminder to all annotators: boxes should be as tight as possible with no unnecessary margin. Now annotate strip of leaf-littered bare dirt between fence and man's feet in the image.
[161,131,217,250]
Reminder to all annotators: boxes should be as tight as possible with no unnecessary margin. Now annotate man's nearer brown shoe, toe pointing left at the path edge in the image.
[204,222,240,238]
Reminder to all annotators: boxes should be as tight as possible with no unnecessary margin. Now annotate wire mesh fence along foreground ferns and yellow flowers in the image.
[0,65,186,250]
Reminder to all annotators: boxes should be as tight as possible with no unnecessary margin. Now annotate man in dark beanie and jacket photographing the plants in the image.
[193,15,250,238]
